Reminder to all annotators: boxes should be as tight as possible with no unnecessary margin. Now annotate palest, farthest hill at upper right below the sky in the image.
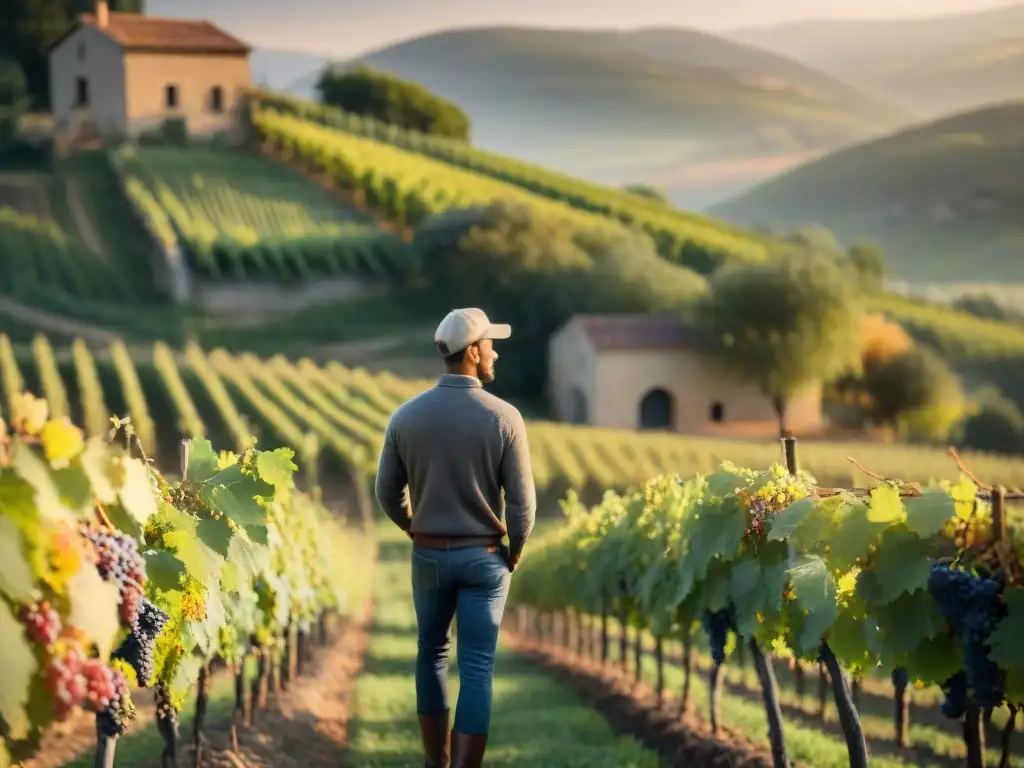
[728,3,1024,117]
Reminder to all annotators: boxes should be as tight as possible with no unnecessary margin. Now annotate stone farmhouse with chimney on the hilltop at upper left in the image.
[49,0,252,147]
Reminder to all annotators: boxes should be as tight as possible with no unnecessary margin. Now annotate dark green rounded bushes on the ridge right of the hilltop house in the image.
[316,66,470,141]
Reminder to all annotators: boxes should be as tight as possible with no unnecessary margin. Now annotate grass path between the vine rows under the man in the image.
[345,522,658,768]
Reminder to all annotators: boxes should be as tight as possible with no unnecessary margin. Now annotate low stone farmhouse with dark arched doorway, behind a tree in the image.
[548,313,824,437]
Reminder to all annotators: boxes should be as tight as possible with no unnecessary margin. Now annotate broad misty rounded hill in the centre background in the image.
[276,27,910,206]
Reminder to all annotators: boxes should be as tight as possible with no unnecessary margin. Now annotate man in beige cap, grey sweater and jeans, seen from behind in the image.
[376,308,537,768]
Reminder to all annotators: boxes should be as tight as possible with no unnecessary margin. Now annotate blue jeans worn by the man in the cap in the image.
[412,547,512,735]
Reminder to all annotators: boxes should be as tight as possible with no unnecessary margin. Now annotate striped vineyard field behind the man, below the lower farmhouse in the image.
[0,336,1024,497]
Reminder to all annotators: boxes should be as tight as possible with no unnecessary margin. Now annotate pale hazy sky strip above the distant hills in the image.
[146,0,1009,55]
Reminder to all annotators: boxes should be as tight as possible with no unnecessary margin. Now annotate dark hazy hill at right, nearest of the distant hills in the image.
[714,101,1024,283]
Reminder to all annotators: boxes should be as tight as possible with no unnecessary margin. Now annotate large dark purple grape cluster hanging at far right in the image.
[928,562,1005,710]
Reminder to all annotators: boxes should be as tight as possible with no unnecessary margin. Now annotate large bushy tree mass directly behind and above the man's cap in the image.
[415,202,703,397]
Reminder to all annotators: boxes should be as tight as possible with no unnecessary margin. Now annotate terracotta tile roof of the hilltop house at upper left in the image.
[79,12,252,54]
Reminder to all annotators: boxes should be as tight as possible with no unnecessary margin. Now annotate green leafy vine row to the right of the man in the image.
[510,463,1022,702]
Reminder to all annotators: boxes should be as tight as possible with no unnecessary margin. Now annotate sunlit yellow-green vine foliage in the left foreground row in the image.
[0,394,360,760]
